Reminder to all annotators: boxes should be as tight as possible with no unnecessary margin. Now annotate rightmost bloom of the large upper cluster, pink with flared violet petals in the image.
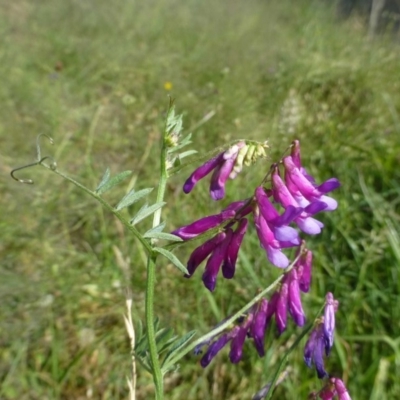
[283,156,340,211]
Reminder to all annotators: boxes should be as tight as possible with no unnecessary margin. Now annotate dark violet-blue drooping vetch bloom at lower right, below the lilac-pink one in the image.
[304,322,328,379]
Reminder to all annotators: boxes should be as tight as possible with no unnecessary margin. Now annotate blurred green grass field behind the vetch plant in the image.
[0,0,400,400]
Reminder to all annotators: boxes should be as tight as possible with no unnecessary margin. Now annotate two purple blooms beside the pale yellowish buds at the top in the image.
[183,142,246,200]
